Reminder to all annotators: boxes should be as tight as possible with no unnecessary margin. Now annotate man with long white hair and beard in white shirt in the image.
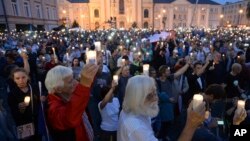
[117,75,205,141]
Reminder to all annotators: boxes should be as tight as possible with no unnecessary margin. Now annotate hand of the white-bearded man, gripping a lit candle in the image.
[186,101,206,129]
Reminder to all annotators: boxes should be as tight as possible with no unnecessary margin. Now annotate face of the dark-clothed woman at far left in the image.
[14,72,28,88]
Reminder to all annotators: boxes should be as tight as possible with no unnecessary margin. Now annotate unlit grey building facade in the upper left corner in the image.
[0,0,58,30]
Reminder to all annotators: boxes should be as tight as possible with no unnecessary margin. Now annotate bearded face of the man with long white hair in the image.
[142,87,159,117]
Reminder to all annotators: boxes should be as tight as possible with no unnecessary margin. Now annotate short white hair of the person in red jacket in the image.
[45,65,73,94]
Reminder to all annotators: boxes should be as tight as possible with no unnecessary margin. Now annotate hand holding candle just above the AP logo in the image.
[233,108,247,125]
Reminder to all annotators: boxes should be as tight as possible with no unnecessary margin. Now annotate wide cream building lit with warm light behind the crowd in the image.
[57,0,222,29]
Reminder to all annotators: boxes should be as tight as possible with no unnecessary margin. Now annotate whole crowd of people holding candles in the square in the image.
[0,28,250,141]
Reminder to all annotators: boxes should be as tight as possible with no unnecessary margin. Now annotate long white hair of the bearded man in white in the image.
[123,75,155,114]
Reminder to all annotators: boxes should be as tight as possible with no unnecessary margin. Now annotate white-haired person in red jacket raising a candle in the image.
[45,64,98,141]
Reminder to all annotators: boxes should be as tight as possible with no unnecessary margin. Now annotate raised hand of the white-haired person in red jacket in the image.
[80,64,99,87]
